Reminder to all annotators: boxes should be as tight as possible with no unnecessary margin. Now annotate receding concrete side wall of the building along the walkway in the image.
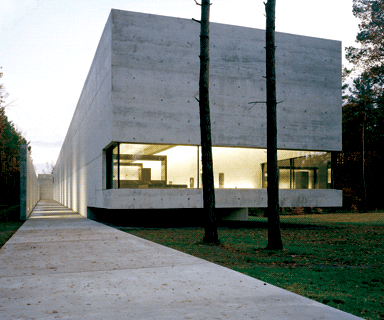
[54,13,112,216]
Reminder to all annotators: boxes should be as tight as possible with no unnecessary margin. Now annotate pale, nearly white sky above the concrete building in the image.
[0,0,359,173]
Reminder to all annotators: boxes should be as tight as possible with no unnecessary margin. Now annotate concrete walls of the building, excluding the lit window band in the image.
[54,10,341,215]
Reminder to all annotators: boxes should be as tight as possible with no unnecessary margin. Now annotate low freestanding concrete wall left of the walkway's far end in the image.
[20,145,40,220]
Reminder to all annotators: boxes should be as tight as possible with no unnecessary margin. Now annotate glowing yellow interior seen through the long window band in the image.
[106,143,331,189]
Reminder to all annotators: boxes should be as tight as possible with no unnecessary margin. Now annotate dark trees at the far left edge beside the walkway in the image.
[0,72,28,205]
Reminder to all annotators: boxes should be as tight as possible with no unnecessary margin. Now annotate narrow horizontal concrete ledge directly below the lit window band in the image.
[100,189,342,209]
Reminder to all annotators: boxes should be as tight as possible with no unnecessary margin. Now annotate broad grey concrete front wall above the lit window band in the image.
[112,11,342,151]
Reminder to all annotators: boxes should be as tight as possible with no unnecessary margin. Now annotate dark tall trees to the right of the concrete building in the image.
[340,0,384,211]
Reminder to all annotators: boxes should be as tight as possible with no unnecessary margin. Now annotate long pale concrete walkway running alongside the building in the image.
[0,201,360,320]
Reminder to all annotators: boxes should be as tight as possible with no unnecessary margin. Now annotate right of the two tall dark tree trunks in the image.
[266,0,283,250]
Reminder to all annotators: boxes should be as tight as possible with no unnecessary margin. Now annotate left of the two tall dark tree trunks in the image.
[199,0,219,243]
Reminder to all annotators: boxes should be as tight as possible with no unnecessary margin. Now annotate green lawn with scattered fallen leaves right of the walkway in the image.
[120,213,384,319]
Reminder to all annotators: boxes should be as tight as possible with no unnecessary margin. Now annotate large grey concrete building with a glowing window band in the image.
[54,10,342,219]
